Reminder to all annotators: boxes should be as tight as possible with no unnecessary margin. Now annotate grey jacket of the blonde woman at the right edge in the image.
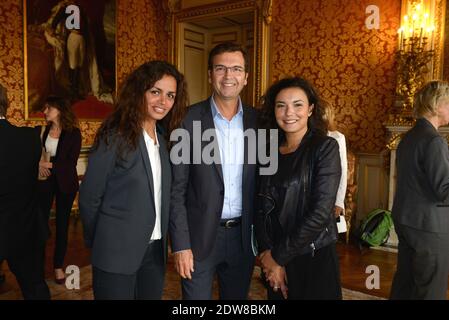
[392,118,449,233]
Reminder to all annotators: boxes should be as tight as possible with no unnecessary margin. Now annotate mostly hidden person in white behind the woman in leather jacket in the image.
[324,103,348,218]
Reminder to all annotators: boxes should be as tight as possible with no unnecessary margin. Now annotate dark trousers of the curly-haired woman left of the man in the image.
[92,240,165,300]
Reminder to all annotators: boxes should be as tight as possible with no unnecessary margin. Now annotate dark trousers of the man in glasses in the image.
[182,225,254,300]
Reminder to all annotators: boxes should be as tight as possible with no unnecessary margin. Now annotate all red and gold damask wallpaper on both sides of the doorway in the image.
[0,0,401,153]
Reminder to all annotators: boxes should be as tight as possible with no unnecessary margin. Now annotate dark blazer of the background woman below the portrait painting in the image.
[36,125,81,193]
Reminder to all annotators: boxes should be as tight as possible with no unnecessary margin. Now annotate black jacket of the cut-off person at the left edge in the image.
[0,120,47,260]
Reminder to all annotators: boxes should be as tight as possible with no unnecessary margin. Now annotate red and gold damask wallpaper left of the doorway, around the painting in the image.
[0,0,168,145]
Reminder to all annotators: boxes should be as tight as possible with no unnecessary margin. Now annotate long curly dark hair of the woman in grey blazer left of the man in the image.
[93,61,188,156]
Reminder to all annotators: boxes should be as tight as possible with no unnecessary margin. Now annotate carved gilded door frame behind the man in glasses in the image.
[170,0,272,105]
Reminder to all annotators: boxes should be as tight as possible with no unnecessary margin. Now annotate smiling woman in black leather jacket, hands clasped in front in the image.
[255,77,341,299]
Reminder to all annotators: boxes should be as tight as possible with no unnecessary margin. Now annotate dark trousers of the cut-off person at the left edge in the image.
[5,241,50,300]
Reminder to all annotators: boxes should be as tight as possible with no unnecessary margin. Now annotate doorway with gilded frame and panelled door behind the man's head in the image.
[169,0,271,106]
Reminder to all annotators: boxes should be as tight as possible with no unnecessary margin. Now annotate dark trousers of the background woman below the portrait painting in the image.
[39,176,76,269]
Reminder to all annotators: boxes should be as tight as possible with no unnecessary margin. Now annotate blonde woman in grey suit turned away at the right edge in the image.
[390,81,449,300]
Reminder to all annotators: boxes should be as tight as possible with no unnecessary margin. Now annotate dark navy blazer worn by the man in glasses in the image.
[170,99,257,261]
